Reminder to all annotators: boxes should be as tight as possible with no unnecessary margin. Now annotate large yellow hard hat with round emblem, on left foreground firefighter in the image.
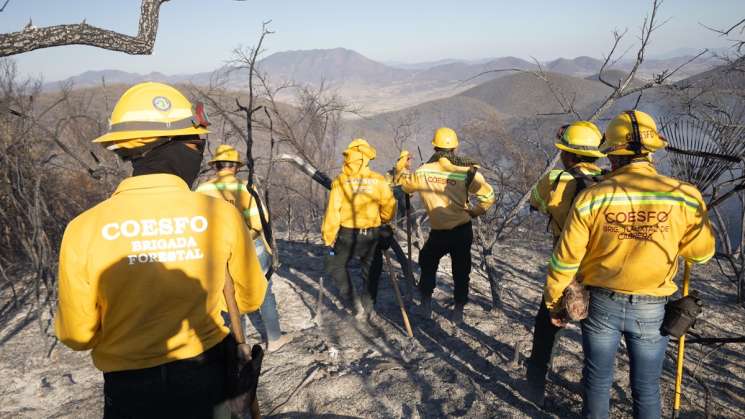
[93,82,209,150]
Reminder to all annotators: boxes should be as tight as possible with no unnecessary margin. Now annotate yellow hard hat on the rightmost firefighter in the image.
[600,110,667,155]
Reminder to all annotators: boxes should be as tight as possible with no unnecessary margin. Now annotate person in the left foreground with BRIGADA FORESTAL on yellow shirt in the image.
[55,83,267,418]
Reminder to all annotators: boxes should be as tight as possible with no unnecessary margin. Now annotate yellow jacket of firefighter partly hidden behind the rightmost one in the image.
[530,162,602,238]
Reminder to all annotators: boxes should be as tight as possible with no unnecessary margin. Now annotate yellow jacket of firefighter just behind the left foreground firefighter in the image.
[196,170,272,253]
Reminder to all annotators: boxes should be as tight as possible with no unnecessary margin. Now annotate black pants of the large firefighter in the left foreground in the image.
[103,337,231,419]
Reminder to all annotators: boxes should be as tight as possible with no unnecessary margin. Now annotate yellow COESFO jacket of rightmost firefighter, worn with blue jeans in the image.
[544,160,714,309]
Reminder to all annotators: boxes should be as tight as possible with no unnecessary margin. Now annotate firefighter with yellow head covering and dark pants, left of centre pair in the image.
[322,138,396,318]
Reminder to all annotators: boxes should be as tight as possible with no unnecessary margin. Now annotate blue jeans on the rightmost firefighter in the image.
[582,287,668,418]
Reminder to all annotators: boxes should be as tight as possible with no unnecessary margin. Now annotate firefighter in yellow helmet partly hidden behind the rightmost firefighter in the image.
[526,121,604,405]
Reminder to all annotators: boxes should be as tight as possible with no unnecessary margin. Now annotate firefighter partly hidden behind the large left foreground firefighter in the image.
[197,144,288,352]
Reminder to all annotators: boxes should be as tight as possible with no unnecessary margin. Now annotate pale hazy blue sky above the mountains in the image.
[0,0,745,81]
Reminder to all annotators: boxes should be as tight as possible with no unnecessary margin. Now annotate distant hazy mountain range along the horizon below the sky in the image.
[45,48,718,90]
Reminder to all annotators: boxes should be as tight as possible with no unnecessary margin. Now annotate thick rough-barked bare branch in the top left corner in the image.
[0,0,168,57]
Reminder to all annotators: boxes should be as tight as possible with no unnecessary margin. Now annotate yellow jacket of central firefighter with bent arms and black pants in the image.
[400,158,494,230]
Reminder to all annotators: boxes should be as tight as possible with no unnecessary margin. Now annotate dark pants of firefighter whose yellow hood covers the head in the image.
[328,227,382,311]
